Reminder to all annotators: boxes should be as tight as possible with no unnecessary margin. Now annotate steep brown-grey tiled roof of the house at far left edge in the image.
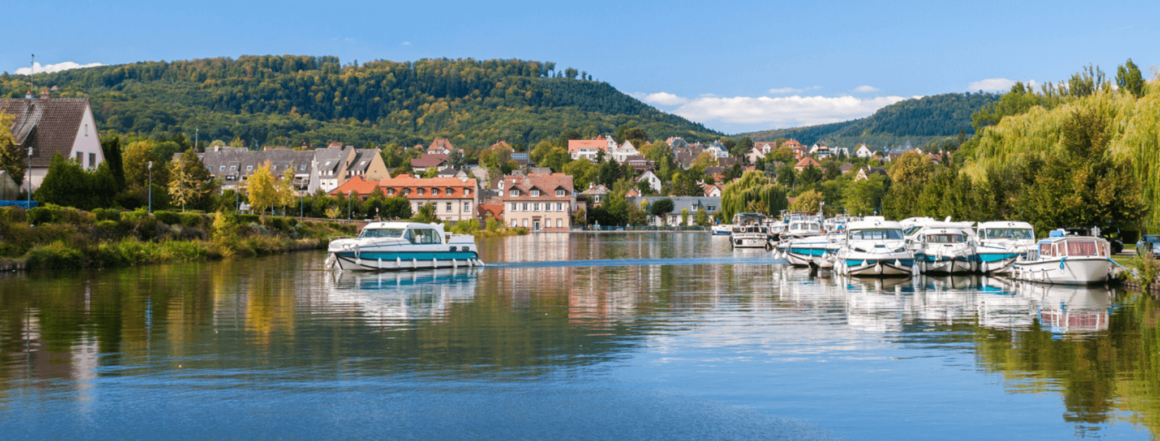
[0,97,96,167]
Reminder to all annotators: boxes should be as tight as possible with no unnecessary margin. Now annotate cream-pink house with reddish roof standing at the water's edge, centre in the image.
[502,173,577,231]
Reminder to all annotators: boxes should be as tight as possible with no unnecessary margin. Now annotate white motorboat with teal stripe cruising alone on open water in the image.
[326,222,484,272]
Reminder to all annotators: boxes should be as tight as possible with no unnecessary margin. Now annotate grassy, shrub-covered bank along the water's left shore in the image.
[0,205,355,269]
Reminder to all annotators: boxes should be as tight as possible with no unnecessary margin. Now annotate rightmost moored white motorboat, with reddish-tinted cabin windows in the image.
[1012,230,1112,284]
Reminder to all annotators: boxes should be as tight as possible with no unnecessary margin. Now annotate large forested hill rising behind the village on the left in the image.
[0,56,720,147]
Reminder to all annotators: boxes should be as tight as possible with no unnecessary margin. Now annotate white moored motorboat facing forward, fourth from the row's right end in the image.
[834,216,914,276]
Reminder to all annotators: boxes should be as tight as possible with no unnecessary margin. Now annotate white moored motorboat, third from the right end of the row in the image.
[908,222,978,274]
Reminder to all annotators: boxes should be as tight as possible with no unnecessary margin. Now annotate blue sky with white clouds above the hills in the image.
[0,0,1160,133]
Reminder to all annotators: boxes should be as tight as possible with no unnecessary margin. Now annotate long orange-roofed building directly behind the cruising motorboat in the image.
[329,174,479,222]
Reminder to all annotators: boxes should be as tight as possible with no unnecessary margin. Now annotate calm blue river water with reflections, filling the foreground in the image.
[0,234,1160,440]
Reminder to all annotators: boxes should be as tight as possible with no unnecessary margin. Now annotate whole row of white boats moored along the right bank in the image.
[713,214,1115,284]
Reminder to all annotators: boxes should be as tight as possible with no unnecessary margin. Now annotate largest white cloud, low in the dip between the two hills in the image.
[674,95,906,129]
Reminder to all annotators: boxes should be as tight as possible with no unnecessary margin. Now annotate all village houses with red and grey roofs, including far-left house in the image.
[0,92,938,231]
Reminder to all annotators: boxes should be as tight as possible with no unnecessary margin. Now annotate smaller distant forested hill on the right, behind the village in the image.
[742,93,1000,147]
